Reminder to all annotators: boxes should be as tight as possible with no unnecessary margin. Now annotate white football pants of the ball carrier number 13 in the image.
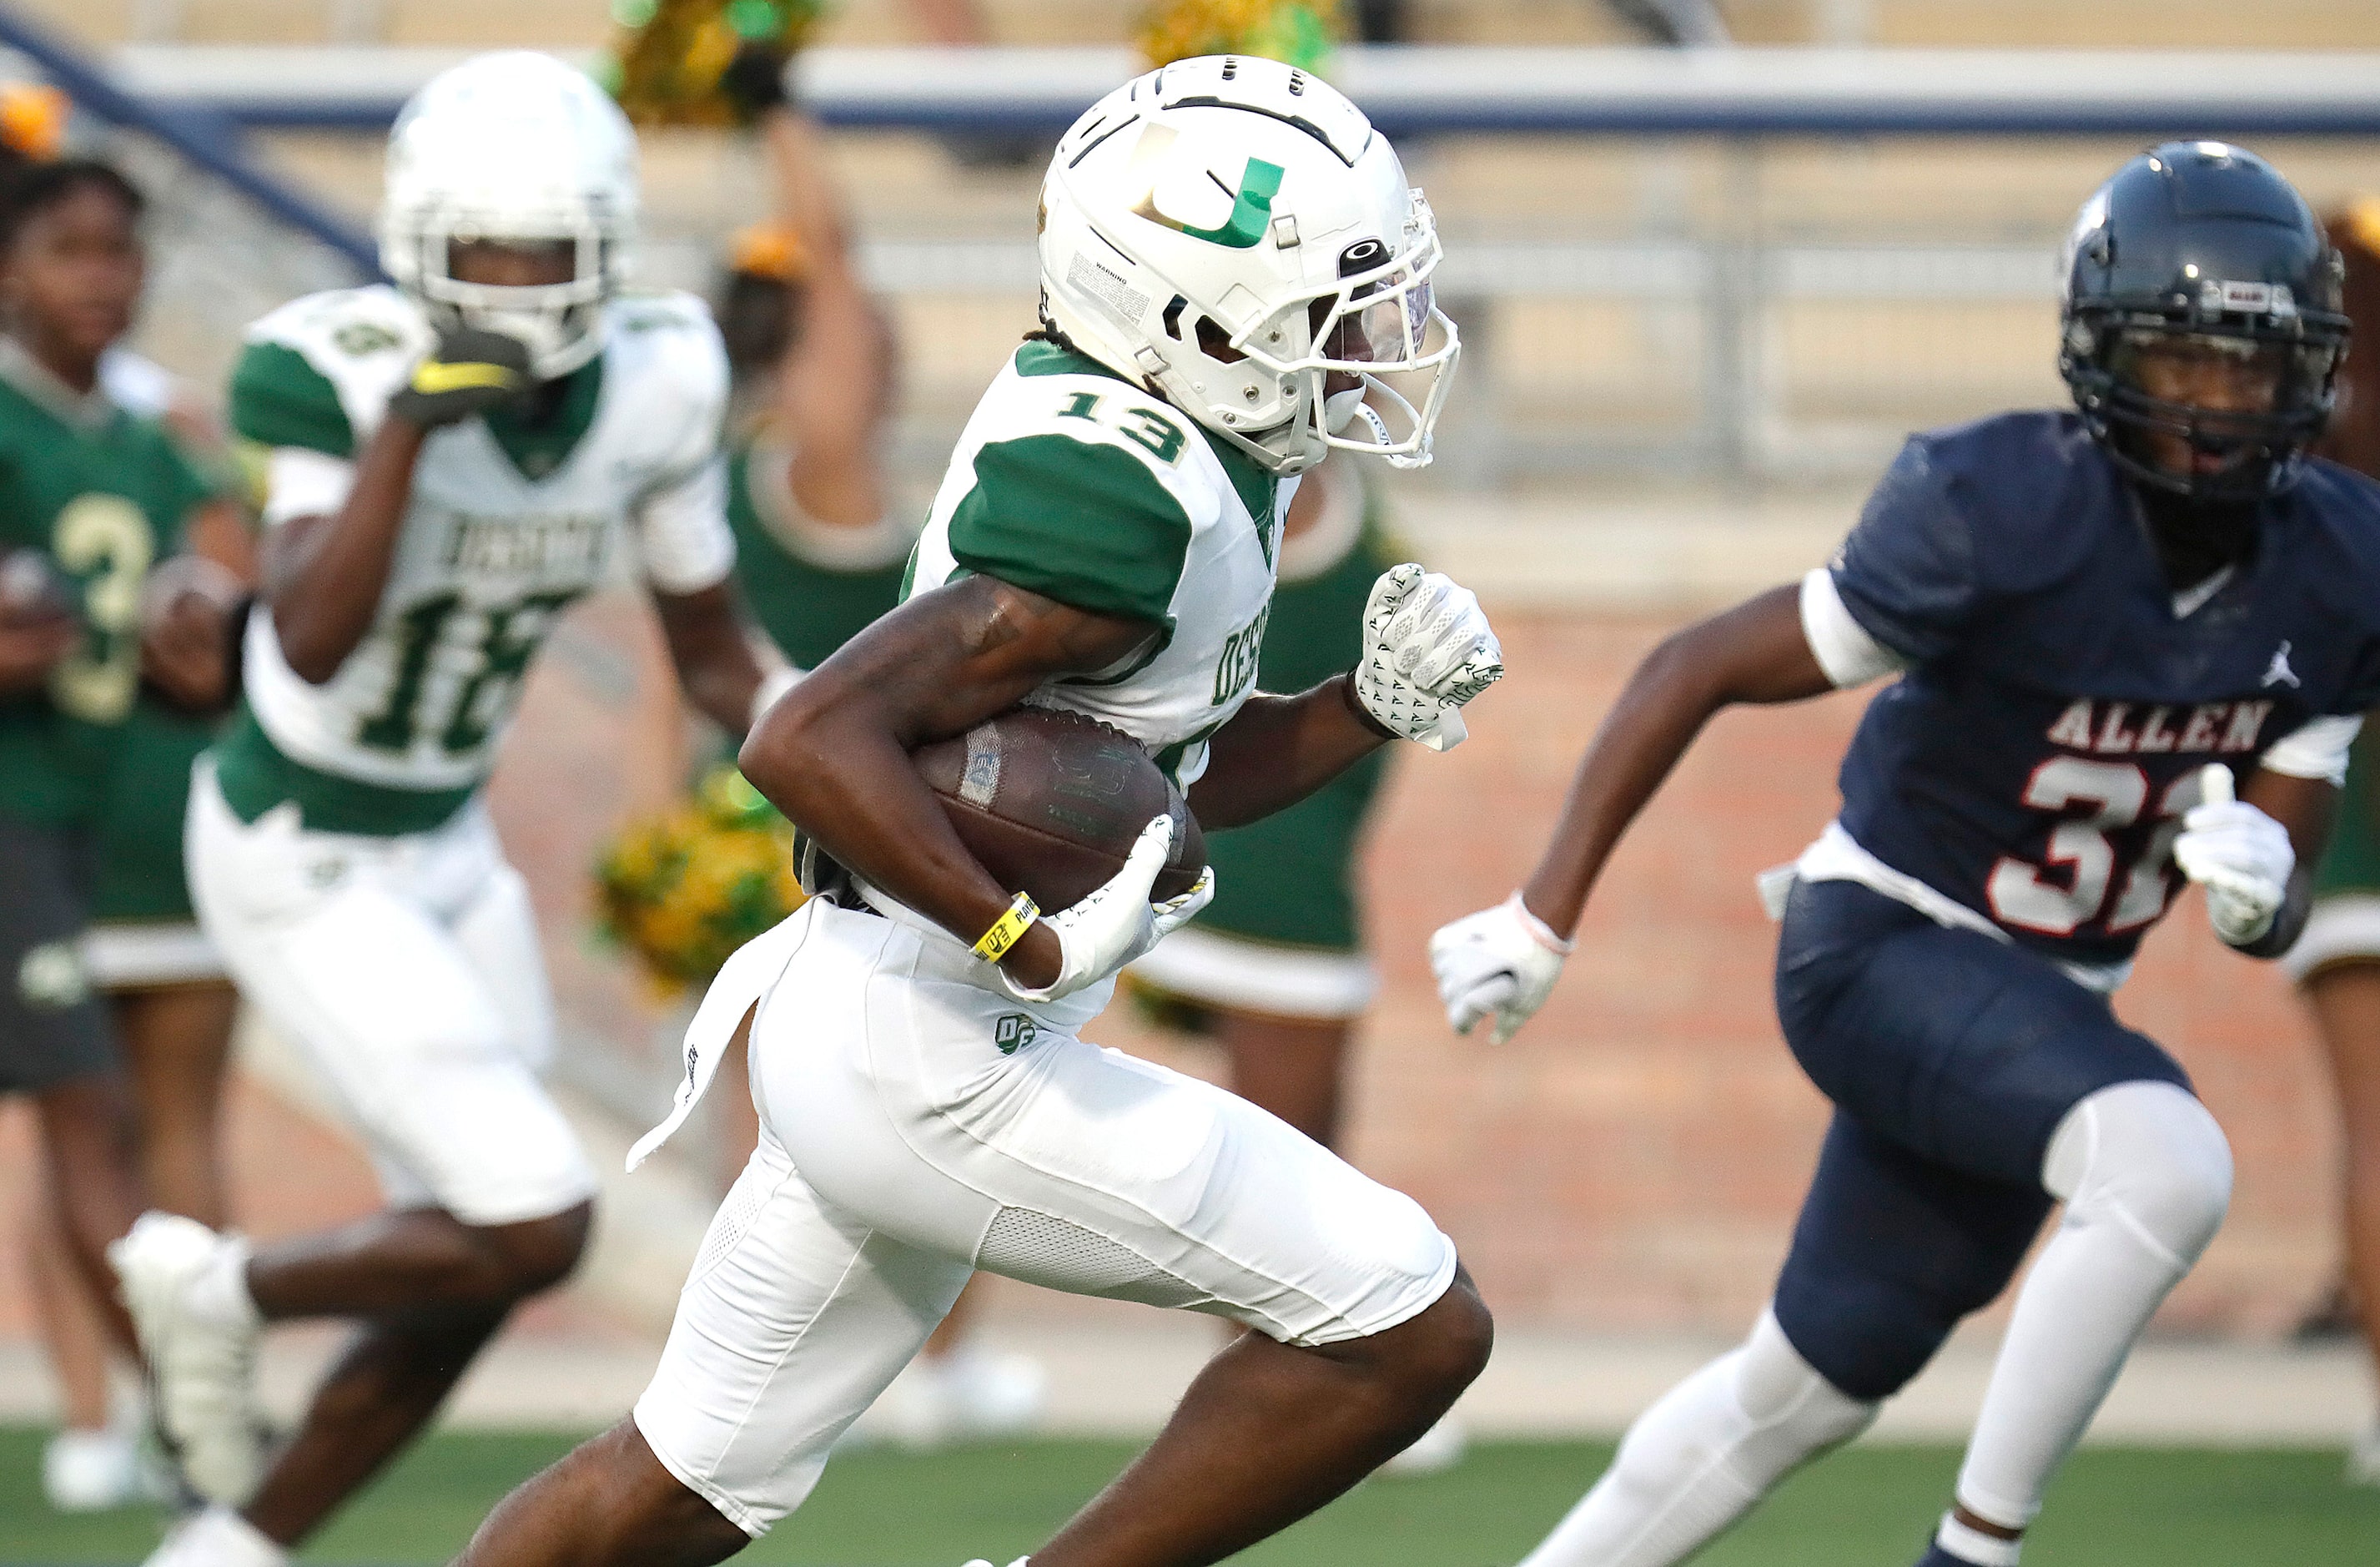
[636,900,1454,1536]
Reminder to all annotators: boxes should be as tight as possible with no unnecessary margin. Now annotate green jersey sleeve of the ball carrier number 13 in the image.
[949,436,1190,624]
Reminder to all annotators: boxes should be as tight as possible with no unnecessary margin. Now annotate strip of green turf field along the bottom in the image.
[0,1428,2380,1567]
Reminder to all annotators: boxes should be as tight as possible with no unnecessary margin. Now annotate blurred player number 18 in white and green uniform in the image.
[117,53,787,1567]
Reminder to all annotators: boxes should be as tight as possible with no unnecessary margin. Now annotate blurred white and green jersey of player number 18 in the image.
[217,285,736,834]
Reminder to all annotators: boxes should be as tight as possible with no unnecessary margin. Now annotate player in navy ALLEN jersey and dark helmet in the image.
[1431,143,2380,1567]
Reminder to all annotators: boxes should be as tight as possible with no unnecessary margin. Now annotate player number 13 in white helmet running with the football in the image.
[464,57,1502,1567]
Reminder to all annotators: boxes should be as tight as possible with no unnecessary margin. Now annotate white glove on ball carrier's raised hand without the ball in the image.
[1354,562,1504,750]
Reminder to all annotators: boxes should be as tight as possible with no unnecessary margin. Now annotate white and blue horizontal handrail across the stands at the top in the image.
[119,45,2380,136]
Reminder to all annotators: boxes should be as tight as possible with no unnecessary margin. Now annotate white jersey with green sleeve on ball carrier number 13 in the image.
[909,340,1297,789]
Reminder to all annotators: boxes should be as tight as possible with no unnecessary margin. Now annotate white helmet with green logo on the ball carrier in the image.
[1040,55,1462,474]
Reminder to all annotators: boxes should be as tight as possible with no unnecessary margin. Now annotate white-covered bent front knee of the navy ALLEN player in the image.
[2042,1081,2232,1267]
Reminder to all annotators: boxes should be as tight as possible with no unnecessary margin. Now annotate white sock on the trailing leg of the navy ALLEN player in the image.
[1521,1313,1878,1567]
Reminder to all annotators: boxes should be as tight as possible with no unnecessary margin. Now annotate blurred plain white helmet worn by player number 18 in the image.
[380,50,636,381]
